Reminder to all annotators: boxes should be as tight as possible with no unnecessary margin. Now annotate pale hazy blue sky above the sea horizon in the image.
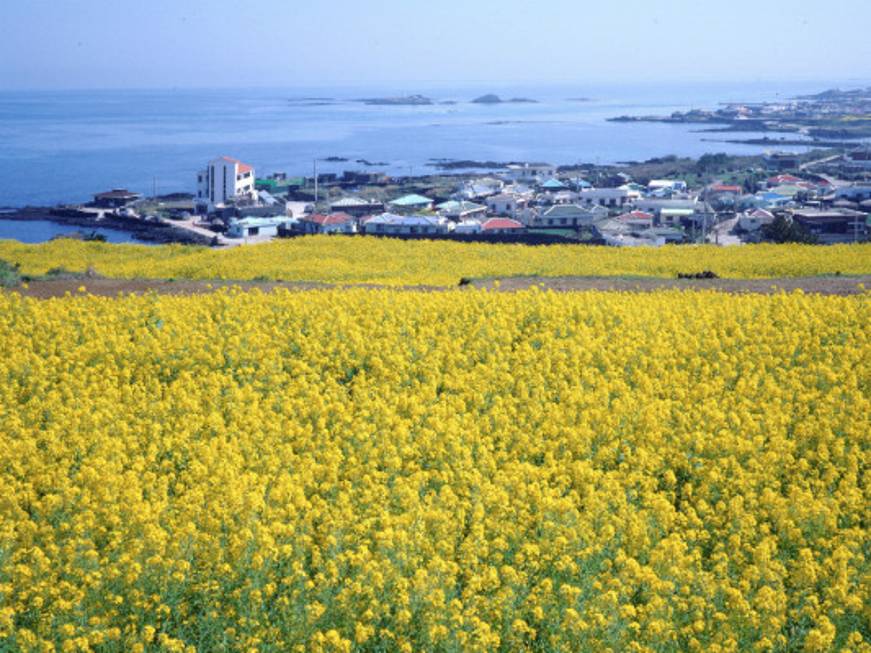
[0,0,871,90]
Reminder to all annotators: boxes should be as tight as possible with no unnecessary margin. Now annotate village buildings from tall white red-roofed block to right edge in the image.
[181,153,871,246]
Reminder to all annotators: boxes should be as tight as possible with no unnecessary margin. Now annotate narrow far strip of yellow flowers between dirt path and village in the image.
[0,236,871,286]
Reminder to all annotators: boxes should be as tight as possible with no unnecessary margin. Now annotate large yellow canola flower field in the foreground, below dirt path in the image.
[0,288,871,653]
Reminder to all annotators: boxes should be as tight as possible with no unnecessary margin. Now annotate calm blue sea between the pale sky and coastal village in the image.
[0,80,868,206]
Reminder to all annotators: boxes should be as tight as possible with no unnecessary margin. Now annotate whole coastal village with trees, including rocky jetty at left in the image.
[39,147,871,247]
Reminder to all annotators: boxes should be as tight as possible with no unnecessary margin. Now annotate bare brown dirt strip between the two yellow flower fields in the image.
[9,275,871,299]
